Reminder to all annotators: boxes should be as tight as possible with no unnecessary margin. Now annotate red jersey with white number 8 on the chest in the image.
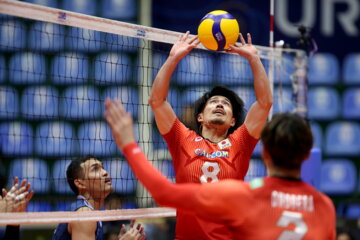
[163,119,258,240]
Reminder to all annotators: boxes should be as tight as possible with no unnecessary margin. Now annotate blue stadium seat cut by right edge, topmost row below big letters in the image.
[343,53,360,85]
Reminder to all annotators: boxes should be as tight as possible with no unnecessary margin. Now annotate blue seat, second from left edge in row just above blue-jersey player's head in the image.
[35,122,77,157]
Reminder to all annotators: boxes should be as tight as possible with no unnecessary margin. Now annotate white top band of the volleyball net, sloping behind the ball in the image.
[0,0,304,59]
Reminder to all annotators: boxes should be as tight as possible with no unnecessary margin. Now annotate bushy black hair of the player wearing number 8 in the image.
[194,86,246,135]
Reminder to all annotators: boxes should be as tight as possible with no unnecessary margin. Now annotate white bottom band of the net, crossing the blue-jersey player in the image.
[0,208,176,225]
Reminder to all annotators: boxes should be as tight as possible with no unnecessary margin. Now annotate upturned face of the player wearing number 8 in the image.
[198,96,235,127]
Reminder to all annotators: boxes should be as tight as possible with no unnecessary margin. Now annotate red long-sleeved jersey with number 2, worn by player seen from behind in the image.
[124,143,336,240]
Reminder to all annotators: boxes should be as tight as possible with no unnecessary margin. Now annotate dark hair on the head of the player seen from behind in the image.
[261,113,314,170]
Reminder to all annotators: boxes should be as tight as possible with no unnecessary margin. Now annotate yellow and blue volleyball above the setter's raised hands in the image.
[198,10,240,51]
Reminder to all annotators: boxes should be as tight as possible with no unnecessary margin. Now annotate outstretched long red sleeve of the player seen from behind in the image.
[123,143,248,222]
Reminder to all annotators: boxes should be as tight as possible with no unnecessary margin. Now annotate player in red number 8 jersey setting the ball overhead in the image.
[149,32,272,240]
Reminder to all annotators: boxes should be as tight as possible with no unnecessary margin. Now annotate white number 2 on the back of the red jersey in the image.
[276,211,308,240]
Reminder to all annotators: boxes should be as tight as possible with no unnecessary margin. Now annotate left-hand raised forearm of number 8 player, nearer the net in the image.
[149,57,178,109]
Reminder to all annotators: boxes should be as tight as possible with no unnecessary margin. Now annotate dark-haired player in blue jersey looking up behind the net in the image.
[53,155,146,240]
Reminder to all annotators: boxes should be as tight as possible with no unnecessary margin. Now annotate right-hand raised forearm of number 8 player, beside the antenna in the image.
[248,55,273,109]
